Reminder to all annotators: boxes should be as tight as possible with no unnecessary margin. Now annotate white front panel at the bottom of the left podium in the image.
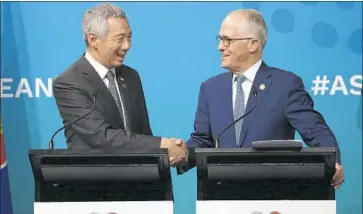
[34,201,173,214]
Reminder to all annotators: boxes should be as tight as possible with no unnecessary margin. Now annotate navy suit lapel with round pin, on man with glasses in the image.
[240,62,271,147]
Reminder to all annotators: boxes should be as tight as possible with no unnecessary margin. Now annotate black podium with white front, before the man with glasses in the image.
[196,148,336,214]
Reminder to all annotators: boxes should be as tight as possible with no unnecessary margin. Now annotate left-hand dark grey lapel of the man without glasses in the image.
[80,56,123,127]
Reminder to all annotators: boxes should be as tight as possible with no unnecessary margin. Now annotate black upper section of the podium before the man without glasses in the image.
[29,149,173,202]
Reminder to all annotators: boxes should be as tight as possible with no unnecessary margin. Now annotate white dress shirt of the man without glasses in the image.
[84,52,126,128]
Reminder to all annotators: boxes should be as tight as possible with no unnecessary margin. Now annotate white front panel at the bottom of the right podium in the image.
[196,200,336,214]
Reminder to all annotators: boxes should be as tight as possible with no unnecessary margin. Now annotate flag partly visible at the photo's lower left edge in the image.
[0,120,13,214]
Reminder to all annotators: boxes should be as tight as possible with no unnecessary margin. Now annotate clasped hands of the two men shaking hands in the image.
[160,138,188,167]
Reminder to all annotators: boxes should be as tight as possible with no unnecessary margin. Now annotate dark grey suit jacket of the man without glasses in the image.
[53,56,161,149]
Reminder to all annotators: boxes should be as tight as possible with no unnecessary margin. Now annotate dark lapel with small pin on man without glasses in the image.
[116,67,132,131]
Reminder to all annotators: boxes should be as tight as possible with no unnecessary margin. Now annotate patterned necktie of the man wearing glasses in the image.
[233,75,246,146]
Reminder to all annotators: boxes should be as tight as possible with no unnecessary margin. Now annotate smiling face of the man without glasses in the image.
[88,17,132,68]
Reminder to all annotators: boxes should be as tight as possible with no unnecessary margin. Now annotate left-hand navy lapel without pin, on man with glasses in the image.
[218,72,236,148]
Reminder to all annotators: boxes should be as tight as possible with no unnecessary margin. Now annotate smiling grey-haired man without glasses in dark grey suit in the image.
[53,4,187,161]
